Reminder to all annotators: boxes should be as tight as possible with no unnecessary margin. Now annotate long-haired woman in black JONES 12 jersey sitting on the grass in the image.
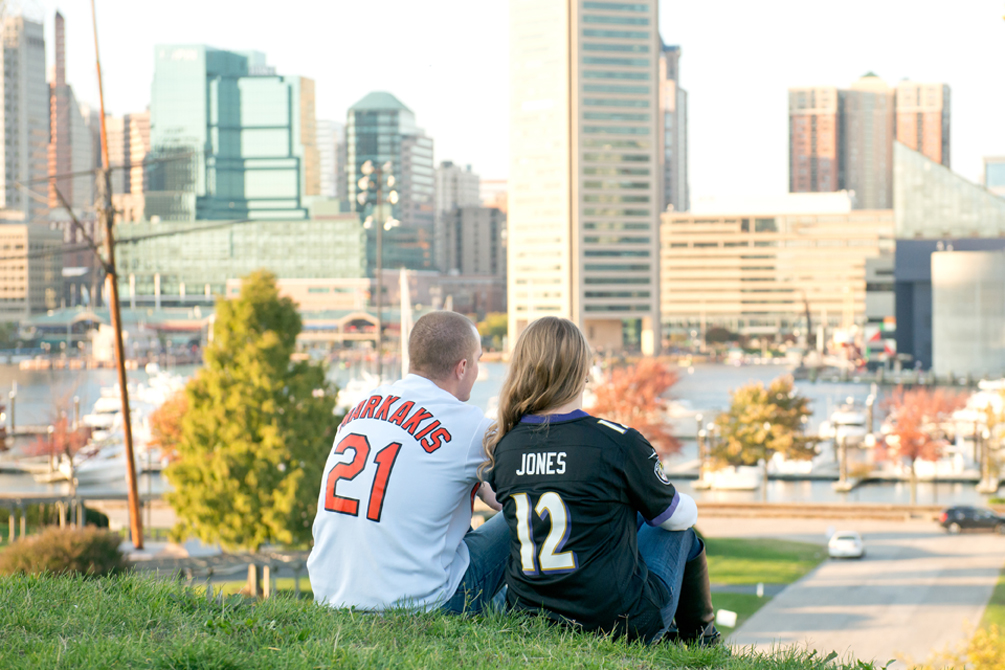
[482,316,719,644]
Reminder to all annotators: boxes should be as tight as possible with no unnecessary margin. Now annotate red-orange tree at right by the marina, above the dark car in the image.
[882,387,966,504]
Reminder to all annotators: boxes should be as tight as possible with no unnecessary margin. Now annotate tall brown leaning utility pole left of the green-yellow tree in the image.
[90,0,143,549]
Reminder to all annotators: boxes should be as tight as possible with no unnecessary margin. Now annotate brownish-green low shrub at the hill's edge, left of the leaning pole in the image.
[0,527,128,577]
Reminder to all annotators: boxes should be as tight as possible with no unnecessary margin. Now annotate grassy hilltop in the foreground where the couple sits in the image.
[0,575,872,670]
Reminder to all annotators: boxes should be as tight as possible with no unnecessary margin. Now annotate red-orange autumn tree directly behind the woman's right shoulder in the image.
[587,359,680,456]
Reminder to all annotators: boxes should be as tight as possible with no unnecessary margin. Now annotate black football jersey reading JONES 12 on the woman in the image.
[486,410,679,638]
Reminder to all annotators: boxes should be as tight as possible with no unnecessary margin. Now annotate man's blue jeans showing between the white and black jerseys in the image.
[440,512,510,614]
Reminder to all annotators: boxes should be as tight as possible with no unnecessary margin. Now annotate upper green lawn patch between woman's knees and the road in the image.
[705,537,827,584]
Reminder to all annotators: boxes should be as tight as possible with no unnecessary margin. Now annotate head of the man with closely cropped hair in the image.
[408,310,480,380]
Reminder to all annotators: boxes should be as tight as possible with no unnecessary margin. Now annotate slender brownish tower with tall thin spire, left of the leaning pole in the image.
[47,12,95,209]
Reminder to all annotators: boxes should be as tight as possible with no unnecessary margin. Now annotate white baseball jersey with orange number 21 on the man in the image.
[308,375,490,610]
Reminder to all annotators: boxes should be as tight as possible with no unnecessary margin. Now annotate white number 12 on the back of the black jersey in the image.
[513,491,579,575]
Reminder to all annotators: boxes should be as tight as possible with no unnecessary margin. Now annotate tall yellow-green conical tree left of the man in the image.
[165,271,338,550]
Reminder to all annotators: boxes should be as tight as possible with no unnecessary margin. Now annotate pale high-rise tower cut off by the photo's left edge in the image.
[0,15,49,221]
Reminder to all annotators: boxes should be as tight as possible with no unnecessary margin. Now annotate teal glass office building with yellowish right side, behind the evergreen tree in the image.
[145,45,320,221]
